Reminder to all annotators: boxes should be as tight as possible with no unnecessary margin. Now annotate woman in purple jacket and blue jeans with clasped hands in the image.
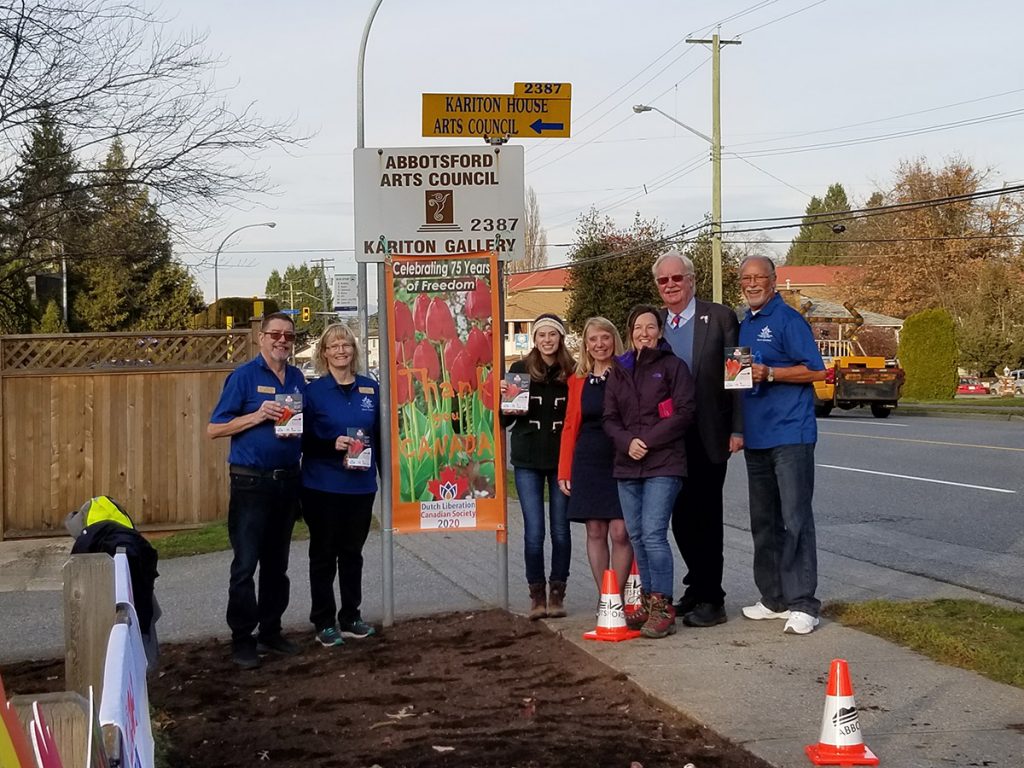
[604,304,694,638]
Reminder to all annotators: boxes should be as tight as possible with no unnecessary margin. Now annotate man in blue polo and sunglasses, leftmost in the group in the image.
[206,312,306,669]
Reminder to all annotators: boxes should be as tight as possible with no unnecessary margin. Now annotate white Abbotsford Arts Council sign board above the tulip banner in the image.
[353,145,525,262]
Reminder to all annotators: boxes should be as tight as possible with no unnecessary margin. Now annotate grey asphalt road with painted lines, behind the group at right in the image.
[726,411,1024,603]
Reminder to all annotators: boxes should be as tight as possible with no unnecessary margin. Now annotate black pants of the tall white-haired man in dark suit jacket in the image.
[672,438,729,605]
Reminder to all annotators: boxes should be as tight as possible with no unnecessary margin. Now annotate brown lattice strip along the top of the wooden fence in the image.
[2,330,251,373]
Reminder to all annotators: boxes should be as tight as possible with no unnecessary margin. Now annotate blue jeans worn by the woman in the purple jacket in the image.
[618,477,683,598]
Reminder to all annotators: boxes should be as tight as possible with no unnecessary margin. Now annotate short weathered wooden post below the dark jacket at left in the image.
[63,552,116,709]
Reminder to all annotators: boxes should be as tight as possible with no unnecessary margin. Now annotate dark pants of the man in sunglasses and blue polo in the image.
[227,473,300,642]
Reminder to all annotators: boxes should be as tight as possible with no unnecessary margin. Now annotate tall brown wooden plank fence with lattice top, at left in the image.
[0,328,256,540]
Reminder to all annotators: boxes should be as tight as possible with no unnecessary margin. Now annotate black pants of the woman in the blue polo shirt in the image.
[302,488,377,631]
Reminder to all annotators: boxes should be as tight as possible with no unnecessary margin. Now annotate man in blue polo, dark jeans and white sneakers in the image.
[739,256,825,635]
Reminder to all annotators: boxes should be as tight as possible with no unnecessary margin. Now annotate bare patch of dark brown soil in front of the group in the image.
[2,610,769,768]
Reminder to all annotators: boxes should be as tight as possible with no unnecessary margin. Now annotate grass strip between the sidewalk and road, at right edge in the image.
[822,600,1024,688]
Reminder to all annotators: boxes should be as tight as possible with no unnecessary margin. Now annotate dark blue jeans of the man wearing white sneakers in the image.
[744,442,821,616]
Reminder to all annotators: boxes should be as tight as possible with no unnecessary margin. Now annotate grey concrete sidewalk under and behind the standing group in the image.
[0,504,1024,768]
